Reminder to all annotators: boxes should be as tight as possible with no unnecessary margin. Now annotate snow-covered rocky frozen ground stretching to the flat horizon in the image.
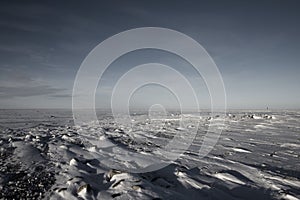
[0,110,300,200]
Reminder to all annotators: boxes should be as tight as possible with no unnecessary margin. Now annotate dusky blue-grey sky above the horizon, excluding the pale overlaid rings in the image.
[0,0,300,109]
